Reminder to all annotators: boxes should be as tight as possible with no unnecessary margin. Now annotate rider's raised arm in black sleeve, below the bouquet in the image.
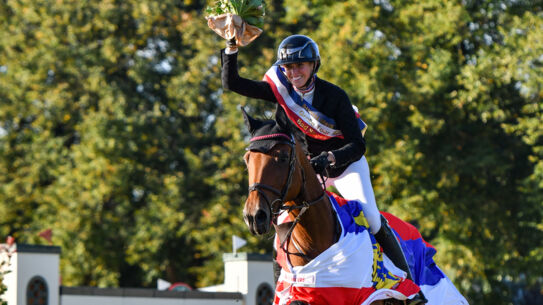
[221,49,276,102]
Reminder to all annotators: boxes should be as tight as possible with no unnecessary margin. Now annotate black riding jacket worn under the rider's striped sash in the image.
[221,49,366,178]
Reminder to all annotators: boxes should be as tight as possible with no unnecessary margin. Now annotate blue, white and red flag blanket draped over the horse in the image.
[274,193,468,305]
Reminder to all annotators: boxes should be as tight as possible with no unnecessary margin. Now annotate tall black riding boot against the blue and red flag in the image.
[373,215,428,305]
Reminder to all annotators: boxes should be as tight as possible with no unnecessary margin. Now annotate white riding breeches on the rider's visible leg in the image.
[326,156,381,234]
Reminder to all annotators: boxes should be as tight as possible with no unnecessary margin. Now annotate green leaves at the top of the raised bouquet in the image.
[206,0,265,28]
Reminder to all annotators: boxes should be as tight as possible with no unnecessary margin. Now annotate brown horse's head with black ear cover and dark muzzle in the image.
[243,111,303,235]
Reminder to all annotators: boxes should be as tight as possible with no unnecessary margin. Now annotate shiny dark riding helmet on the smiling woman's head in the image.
[274,35,321,74]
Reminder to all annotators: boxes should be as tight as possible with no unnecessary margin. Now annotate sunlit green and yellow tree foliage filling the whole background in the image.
[0,0,543,304]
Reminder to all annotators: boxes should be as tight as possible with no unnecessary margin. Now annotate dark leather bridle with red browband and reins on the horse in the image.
[249,133,326,260]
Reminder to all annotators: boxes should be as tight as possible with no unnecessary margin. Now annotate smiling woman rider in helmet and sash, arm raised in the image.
[221,35,425,304]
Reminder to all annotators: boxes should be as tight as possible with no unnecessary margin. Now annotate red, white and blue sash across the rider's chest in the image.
[264,66,367,140]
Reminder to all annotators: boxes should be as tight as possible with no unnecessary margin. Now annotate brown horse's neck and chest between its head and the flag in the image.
[282,145,336,266]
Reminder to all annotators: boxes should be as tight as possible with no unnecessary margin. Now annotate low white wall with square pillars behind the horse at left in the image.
[0,244,274,305]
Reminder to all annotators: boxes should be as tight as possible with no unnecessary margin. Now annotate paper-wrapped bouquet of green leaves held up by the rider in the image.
[206,0,265,46]
